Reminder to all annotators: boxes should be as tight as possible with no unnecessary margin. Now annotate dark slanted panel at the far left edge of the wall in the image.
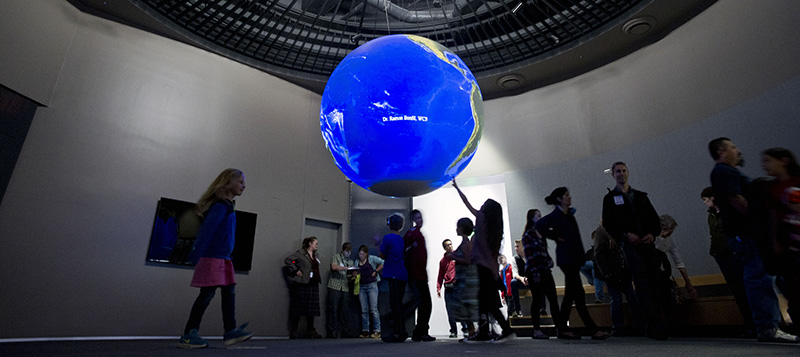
[0,86,36,202]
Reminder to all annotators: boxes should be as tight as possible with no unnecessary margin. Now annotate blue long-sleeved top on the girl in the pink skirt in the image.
[189,200,236,264]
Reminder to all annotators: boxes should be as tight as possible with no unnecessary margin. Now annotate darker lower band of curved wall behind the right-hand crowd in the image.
[505,77,800,282]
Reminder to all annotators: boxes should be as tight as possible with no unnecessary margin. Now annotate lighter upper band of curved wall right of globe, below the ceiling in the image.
[463,0,800,177]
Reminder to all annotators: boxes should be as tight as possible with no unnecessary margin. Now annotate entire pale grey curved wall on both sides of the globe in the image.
[0,0,800,338]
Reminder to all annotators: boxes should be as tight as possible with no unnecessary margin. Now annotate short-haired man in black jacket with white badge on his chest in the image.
[603,162,667,340]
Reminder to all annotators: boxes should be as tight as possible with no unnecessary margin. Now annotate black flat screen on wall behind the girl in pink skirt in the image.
[147,197,257,272]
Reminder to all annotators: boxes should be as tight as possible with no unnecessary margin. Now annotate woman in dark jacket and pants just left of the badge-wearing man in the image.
[534,187,611,340]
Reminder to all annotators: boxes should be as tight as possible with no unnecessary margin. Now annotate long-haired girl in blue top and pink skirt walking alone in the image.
[178,169,253,348]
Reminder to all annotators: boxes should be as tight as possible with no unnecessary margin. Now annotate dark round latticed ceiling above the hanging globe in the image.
[71,0,714,99]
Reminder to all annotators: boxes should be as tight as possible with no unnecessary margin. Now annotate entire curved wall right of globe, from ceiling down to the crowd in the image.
[476,1,800,282]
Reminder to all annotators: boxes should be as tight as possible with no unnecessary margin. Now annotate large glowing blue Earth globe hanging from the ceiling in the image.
[320,35,483,197]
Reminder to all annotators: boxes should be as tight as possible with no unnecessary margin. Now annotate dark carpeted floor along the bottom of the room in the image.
[0,337,800,357]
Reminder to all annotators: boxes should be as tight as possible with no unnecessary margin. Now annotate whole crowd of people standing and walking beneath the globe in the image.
[172,138,800,348]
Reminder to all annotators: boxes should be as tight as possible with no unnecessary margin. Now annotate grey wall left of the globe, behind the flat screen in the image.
[0,1,349,337]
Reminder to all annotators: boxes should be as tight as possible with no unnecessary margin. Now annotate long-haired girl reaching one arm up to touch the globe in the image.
[453,179,516,343]
